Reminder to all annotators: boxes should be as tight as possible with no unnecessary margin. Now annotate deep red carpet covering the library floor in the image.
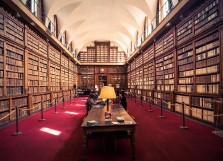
[0,98,223,161]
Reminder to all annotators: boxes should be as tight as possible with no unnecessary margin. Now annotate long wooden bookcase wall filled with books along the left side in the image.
[0,8,77,126]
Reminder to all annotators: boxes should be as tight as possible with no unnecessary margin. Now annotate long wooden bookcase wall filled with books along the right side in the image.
[127,0,223,127]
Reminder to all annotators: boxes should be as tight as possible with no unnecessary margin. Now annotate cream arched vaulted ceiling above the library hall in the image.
[44,0,157,52]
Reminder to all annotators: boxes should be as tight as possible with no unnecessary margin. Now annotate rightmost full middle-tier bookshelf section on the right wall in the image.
[195,32,220,94]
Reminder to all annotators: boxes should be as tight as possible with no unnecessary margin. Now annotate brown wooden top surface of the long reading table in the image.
[81,105,137,128]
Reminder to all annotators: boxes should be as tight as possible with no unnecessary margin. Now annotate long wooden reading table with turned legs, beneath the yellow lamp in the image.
[81,105,136,160]
